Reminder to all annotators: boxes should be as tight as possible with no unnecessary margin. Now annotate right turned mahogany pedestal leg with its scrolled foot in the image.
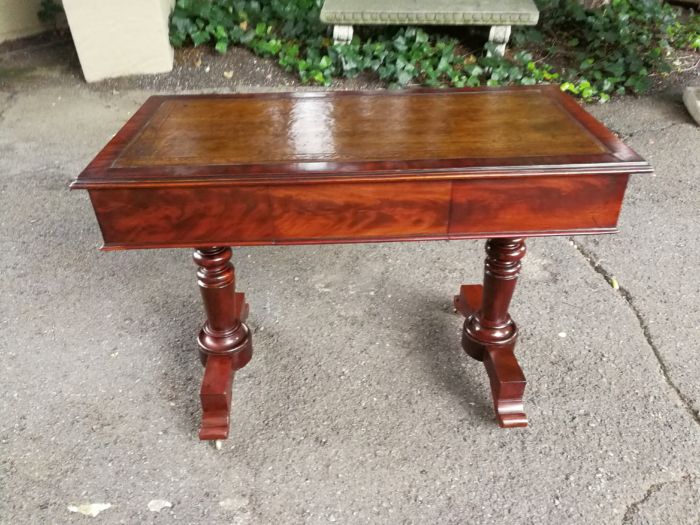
[455,239,527,427]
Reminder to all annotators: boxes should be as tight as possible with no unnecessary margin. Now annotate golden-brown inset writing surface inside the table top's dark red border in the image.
[116,89,607,167]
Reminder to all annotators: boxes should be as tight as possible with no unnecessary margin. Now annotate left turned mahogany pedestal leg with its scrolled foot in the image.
[194,248,253,439]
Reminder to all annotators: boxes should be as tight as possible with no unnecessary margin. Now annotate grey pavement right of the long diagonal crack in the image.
[577,89,700,420]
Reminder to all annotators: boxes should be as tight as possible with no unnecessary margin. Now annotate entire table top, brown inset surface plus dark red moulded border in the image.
[73,86,651,189]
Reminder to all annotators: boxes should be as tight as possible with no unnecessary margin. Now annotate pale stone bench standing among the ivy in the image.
[321,0,539,55]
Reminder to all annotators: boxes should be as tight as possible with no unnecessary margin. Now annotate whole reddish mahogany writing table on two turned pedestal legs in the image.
[72,86,651,439]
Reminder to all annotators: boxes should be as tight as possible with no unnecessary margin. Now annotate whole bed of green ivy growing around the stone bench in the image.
[170,0,700,102]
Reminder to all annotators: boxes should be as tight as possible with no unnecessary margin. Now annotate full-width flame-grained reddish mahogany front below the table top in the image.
[90,175,627,247]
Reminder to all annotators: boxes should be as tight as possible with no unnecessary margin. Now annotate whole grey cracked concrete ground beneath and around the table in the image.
[0,37,700,525]
